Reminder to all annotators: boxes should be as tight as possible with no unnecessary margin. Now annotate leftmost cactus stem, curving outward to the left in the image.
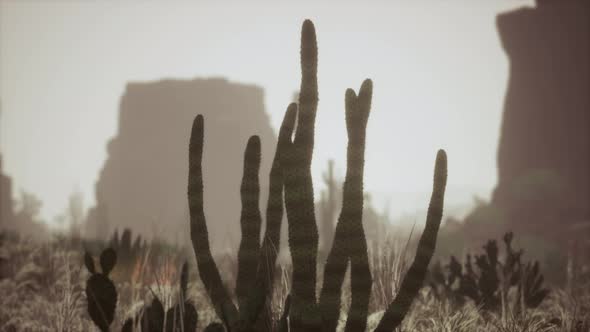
[188,115,238,325]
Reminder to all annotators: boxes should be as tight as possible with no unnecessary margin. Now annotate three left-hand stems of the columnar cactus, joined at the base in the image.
[188,106,296,331]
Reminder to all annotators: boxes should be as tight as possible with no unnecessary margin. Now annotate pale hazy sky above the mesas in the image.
[0,0,532,226]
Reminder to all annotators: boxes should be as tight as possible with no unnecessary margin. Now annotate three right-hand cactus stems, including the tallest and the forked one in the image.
[282,21,447,331]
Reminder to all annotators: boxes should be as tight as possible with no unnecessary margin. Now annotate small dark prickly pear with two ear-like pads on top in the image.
[84,248,117,332]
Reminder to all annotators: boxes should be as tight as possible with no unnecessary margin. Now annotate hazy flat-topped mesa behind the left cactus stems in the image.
[87,79,276,251]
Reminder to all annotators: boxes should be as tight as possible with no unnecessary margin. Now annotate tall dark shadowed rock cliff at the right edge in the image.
[492,0,590,237]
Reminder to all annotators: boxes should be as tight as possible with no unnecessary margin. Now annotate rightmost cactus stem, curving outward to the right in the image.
[375,150,447,332]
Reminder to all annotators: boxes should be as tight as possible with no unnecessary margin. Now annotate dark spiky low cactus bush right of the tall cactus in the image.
[429,232,549,312]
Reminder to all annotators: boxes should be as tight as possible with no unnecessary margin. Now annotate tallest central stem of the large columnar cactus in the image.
[281,20,318,331]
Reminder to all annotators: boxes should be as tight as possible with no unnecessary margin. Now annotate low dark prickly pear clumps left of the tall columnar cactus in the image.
[84,248,198,332]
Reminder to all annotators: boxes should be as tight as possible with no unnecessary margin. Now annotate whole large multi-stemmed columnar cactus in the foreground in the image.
[188,20,447,332]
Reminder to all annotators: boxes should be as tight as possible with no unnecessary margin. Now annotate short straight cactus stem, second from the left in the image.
[236,136,262,311]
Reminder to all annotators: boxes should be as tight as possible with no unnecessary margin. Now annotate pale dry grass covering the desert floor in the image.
[0,231,590,332]
